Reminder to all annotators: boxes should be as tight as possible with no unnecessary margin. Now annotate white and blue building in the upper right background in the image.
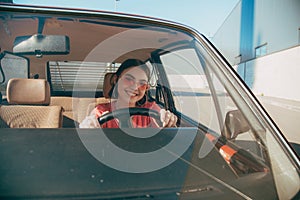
[212,0,300,101]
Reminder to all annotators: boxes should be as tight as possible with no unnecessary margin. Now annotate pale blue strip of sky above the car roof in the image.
[14,0,239,37]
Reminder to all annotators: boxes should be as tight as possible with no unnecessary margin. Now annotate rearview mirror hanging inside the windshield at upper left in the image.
[13,34,70,57]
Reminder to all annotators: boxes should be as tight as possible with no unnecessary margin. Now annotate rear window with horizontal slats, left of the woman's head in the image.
[47,61,120,94]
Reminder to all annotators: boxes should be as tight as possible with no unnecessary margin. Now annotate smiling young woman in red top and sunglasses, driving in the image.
[79,59,177,128]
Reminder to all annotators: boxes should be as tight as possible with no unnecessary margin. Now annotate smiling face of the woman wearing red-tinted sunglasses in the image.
[118,67,149,107]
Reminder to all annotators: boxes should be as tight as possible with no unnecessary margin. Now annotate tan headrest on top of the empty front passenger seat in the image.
[6,78,50,105]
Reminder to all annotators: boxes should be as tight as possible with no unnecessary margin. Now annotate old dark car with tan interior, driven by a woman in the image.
[0,3,300,200]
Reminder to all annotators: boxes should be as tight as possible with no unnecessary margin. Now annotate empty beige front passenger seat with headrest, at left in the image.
[0,78,62,128]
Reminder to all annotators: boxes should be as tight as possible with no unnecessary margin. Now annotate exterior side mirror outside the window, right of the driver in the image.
[222,110,250,140]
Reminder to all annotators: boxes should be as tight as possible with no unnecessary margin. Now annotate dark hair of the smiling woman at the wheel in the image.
[108,59,150,105]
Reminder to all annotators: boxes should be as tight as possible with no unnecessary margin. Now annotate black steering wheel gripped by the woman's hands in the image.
[98,107,162,128]
